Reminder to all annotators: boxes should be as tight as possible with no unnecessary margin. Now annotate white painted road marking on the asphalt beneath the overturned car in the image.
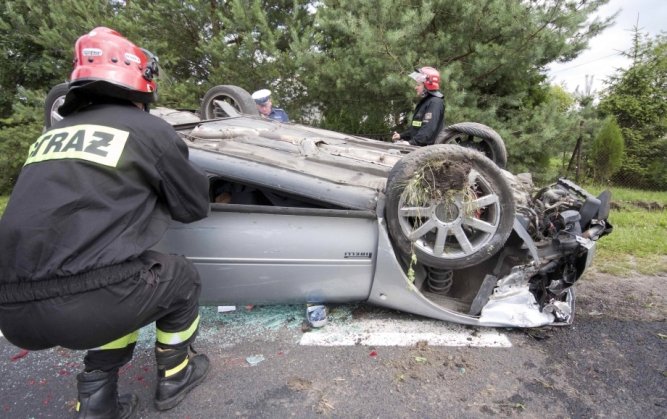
[299,319,512,348]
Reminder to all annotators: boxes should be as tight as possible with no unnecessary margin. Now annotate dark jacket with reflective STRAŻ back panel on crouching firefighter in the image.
[0,104,209,303]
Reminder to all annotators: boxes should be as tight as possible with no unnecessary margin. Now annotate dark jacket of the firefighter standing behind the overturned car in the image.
[401,91,445,146]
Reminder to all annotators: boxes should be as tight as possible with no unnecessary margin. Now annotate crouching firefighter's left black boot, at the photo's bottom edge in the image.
[76,371,139,419]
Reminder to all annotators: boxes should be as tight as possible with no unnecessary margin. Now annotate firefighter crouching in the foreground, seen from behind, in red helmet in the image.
[0,27,209,417]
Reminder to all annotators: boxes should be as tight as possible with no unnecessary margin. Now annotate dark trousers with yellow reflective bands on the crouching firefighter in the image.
[0,251,201,371]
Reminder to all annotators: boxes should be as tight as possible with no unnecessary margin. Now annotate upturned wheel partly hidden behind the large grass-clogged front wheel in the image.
[435,122,507,169]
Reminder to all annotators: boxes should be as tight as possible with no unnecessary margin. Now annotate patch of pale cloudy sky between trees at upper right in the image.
[548,0,667,92]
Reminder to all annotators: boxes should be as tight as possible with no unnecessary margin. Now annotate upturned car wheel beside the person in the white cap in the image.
[199,85,259,119]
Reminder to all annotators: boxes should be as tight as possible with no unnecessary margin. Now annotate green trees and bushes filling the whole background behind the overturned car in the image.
[0,0,667,194]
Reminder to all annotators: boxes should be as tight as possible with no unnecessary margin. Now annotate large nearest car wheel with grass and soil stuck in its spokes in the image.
[386,145,514,269]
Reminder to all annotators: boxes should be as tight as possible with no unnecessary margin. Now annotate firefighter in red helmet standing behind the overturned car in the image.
[391,67,445,146]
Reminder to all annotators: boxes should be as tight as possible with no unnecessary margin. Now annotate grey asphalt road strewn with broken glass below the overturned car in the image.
[0,296,667,418]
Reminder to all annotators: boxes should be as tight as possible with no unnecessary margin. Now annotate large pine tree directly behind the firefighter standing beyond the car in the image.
[294,0,610,166]
